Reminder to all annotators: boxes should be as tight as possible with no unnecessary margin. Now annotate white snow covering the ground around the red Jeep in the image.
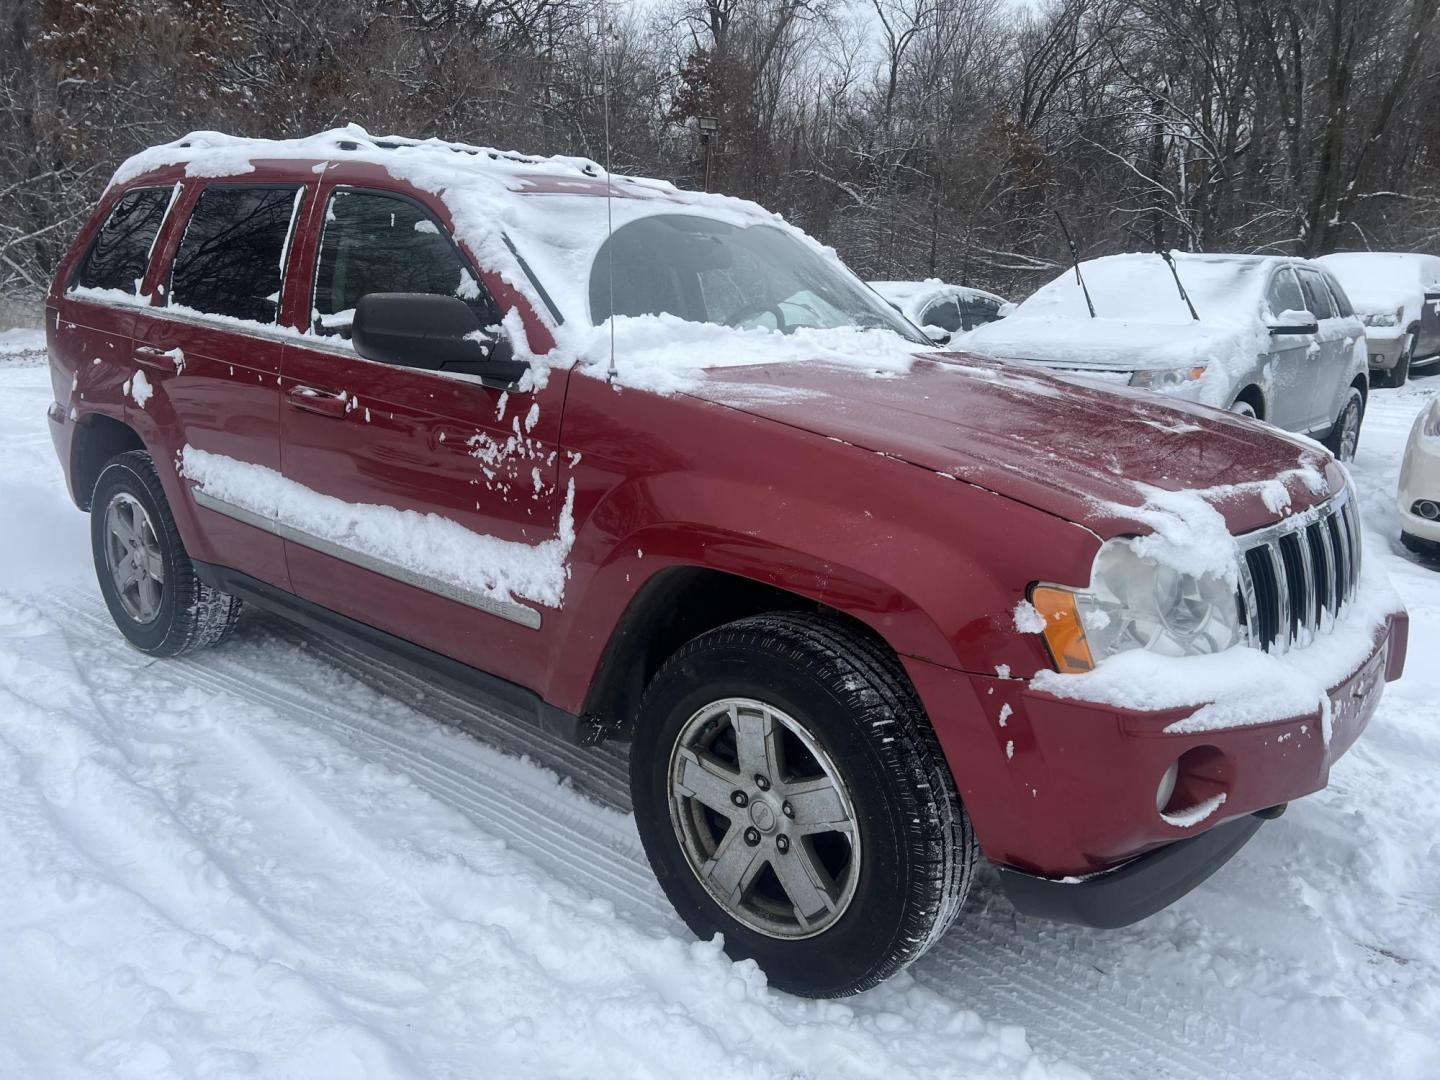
[0,350,1440,1080]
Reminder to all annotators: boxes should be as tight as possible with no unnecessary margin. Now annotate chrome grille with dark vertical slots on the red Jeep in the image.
[1238,488,1361,652]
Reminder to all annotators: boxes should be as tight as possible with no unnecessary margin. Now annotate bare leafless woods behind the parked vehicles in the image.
[0,0,1440,302]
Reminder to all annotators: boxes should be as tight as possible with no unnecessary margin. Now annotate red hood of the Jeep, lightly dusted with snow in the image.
[685,353,1345,537]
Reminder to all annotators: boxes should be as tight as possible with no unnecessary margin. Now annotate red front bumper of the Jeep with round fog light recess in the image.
[906,613,1408,924]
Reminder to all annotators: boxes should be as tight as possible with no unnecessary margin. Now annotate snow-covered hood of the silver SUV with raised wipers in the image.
[965,315,1253,372]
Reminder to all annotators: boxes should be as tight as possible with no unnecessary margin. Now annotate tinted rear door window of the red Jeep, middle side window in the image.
[170,184,301,323]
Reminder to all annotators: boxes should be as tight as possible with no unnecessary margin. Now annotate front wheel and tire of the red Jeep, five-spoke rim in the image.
[631,613,978,998]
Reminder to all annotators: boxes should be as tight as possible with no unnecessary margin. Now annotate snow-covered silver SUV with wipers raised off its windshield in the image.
[965,252,1368,461]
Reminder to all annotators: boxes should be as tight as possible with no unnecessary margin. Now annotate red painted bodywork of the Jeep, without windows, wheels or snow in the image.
[48,154,1405,898]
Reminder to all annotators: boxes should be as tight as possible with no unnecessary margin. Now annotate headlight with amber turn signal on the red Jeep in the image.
[1030,539,1241,674]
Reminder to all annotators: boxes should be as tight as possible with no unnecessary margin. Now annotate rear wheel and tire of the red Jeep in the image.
[91,451,242,657]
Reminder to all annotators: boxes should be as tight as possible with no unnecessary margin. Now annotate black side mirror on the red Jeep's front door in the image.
[350,292,528,386]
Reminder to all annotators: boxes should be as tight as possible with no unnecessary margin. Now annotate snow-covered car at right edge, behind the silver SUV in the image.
[1318,252,1440,386]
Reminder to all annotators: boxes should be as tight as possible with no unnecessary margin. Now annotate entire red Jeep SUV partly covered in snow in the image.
[48,128,1405,995]
